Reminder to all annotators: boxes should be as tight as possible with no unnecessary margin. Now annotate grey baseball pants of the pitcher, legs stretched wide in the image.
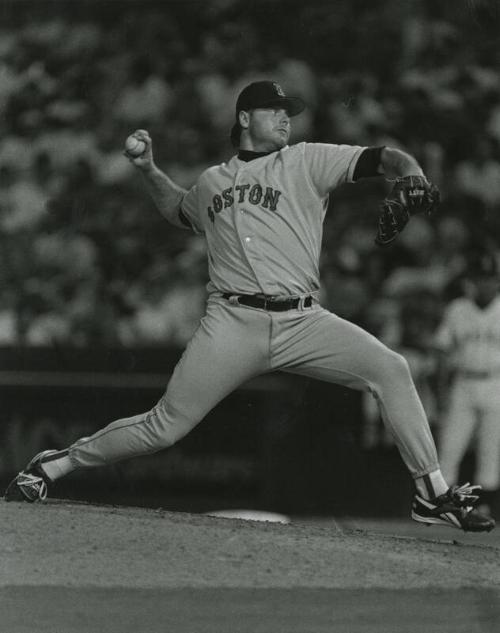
[69,296,438,477]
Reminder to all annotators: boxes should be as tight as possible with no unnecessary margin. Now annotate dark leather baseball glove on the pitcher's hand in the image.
[375,176,439,246]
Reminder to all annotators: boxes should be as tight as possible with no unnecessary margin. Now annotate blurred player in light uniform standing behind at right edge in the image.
[436,251,500,506]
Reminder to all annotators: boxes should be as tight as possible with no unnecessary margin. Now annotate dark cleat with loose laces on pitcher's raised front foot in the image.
[411,483,495,532]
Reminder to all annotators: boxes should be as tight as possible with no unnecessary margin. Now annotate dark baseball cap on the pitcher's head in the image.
[231,81,306,145]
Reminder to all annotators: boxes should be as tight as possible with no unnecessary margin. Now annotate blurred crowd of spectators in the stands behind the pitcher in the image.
[0,0,500,354]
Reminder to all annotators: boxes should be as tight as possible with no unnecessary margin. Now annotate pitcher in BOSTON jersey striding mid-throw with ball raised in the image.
[5,81,494,531]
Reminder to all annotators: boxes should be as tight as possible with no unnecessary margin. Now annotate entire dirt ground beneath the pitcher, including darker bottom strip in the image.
[0,500,500,633]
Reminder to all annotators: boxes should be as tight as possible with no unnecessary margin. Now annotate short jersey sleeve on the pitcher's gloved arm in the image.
[304,143,367,197]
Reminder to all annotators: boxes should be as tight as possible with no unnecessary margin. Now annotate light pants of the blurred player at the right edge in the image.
[439,375,500,490]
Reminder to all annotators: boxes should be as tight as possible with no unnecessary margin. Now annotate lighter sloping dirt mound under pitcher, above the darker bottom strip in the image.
[0,501,500,589]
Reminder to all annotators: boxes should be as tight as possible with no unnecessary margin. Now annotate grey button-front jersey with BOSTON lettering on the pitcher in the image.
[182,143,365,295]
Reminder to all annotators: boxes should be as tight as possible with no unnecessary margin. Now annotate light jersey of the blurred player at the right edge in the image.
[436,297,500,372]
